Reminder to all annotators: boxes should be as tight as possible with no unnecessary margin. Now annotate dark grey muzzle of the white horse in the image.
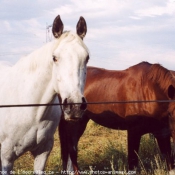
[62,97,87,121]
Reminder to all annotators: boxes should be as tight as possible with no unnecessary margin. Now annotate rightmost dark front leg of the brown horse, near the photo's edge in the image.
[155,135,174,170]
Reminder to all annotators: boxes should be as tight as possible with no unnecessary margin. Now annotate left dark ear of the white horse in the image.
[52,15,64,38]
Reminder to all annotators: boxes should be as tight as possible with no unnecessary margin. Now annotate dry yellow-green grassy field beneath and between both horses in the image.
[14,121,171,175]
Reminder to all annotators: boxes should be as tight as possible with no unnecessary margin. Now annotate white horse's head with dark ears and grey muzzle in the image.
[52,16,89,120]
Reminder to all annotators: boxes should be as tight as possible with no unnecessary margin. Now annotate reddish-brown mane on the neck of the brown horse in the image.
[146,64,175,92]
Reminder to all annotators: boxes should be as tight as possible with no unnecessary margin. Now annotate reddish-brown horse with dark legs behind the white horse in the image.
[59,62,175,174]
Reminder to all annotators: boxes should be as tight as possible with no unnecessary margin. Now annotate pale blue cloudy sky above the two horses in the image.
[0,0,175,70]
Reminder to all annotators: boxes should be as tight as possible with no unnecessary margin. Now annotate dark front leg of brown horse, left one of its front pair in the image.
[128,129,142,170]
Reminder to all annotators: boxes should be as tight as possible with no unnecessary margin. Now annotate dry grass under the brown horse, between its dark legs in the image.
[78,122,170,175]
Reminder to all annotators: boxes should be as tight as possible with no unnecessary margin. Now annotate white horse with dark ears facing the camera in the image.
[0,15,89,174]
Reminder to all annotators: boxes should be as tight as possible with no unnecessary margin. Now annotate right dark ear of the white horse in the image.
[77,16,87,39]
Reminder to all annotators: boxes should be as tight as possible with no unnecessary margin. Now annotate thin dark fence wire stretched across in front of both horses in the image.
[0,100,175,108]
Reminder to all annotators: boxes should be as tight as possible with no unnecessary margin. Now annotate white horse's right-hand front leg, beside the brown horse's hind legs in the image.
[31,139,54,174]
